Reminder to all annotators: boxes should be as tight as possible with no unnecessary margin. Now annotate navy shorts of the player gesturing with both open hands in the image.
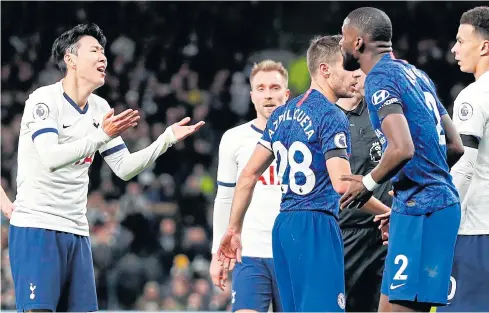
[9,225,98,312]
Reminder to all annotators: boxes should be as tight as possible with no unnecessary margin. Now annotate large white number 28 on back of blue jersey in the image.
[272,141,316,195]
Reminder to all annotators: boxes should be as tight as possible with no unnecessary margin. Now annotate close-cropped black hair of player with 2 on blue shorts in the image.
[347,7,392,41]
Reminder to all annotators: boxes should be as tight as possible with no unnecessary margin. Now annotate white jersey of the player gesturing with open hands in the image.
[10,81,125,236]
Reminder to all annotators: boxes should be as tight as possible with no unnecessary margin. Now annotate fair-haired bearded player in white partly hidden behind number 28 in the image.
[210,60,290,312]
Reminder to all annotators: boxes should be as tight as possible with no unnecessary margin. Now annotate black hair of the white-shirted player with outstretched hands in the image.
[51,24,107,73]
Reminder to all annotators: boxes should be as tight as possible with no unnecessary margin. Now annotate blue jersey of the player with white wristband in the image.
[365,54,459,215]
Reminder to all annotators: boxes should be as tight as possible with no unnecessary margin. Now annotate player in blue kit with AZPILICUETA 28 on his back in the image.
[218,36,389,312]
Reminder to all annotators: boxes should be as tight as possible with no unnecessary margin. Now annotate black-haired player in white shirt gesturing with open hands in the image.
[9,24,204,312]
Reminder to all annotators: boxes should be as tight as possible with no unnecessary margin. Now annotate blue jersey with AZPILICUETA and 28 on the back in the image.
[260,89,350,216]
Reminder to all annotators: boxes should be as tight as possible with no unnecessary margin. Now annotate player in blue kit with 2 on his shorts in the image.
[340,7,464,312]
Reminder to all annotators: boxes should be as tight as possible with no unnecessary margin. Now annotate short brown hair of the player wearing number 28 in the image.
[307,35,341,76]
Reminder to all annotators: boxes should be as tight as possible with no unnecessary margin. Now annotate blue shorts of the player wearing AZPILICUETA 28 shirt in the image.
[272,211,345,312]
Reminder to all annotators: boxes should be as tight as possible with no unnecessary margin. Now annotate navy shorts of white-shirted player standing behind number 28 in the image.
[232,257,282,312]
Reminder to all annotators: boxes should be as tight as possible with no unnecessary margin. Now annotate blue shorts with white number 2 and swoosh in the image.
[382,203,460,305]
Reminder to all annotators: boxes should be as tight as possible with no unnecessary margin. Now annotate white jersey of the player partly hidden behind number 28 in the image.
[212,121,282,258]
